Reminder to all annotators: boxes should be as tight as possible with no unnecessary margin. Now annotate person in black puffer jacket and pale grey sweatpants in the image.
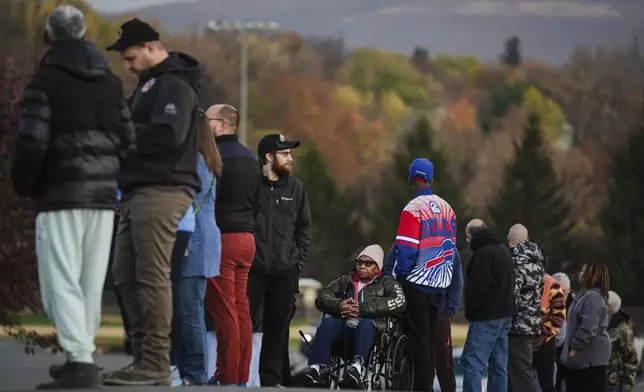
[12,6,136,389]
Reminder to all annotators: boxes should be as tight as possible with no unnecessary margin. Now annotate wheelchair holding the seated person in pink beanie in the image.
[305,316,414,391]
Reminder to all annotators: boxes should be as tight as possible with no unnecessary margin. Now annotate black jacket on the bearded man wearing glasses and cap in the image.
[252,176,311,275]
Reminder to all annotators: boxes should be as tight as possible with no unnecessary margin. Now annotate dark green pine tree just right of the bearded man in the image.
[295,145,364,284]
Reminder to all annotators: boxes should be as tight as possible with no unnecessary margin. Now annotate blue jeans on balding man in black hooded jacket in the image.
[461,317,512,392]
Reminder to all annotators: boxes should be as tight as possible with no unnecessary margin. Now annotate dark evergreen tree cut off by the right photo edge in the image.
[599,125,644,306]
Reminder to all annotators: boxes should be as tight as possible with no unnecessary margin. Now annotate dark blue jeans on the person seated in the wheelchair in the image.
[309,317,376,365]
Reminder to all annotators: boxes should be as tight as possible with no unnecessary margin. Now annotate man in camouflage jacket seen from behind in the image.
[508,224,545,392]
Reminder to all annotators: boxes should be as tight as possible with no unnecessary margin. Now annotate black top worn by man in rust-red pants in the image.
[215,135,262,233]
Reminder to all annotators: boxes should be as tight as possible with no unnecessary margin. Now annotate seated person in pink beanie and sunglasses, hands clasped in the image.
[306,245,406,389]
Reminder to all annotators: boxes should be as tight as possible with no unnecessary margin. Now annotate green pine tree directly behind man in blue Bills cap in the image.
[370,117,468,252]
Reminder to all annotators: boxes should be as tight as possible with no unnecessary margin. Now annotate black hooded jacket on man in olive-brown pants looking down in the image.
[119,53,201,195]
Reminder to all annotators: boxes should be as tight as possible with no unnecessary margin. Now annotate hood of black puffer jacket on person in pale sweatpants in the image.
[40,40,110,80]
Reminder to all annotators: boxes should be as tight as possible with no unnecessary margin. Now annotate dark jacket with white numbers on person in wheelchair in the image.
[315,271,407,332]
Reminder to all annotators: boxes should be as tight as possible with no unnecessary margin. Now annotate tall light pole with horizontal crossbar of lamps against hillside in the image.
[207,20,280,144]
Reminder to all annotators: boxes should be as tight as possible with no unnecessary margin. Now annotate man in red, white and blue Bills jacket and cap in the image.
[386,158,457,391]
